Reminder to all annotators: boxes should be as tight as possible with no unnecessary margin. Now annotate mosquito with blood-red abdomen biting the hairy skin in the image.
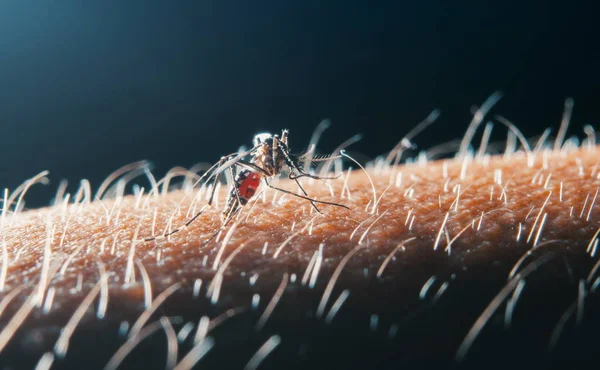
[144,129,349,246]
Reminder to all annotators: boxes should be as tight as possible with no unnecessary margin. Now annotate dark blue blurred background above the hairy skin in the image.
[0,0,600,206]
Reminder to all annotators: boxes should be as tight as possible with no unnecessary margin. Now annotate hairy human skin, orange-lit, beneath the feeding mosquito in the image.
[0,120,600,369]
